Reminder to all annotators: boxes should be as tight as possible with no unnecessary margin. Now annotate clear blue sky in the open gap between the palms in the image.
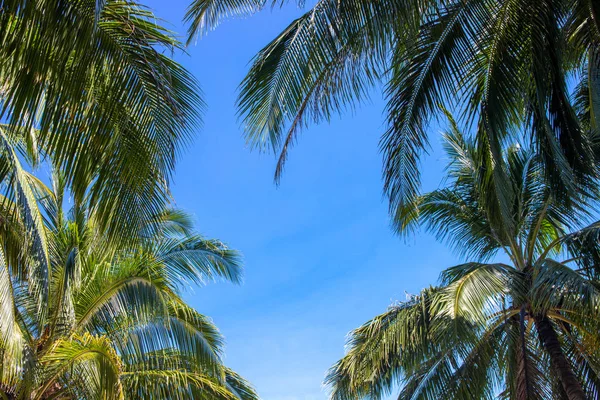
[142,0,457,400]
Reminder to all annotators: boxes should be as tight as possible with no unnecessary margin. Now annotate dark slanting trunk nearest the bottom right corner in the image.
[535,315,586,400]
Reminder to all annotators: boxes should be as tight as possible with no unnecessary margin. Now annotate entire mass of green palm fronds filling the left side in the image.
[0,0,257,400]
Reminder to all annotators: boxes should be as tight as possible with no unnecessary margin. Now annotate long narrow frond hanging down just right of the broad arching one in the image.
[381,0,487,219]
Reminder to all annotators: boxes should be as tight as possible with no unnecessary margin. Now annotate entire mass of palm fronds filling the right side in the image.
[187,0,600,399]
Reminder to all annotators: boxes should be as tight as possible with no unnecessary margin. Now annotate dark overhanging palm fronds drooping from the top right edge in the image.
[186,0,600,219]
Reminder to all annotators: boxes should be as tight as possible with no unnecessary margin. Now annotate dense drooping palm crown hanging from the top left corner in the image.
[0,0,203,241]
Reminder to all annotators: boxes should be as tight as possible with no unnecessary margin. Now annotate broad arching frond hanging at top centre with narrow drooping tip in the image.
[238,0,403,181]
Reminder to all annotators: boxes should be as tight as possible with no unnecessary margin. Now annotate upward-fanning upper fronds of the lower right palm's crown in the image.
[394,114,597,269]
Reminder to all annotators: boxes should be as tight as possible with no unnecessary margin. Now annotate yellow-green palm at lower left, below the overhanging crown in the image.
[0,171,258,400]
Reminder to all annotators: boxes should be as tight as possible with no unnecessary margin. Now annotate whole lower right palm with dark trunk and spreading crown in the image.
[326,122,600,400]
